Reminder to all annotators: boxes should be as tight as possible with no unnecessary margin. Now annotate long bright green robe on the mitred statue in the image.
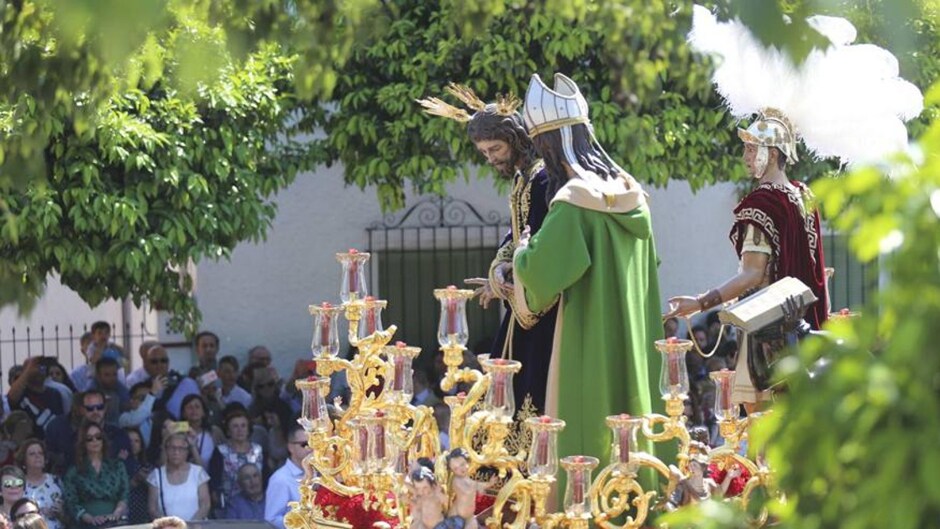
[513,192,669,472]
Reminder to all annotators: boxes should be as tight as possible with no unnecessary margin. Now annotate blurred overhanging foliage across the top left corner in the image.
[0,0,386,190]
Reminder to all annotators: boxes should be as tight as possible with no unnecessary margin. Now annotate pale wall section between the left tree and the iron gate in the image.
[197,166,508,375]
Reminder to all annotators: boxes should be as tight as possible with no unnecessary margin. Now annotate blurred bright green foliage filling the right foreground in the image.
[672,78,940,529]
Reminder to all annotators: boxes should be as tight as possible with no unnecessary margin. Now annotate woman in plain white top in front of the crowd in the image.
[147,433,211,521]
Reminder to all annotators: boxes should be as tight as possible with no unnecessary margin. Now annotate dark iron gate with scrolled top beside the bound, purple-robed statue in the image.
[366,197,509,361]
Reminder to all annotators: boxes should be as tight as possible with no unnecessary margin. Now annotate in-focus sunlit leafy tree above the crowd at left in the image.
[0,7,320,325]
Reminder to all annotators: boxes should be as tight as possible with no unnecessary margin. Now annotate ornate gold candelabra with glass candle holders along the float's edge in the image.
[285,250,772,529]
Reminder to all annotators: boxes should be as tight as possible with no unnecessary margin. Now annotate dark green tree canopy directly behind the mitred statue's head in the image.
[323,0,743,208]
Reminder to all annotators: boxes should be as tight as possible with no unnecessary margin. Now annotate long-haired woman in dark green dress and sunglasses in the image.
[64,420,130,529]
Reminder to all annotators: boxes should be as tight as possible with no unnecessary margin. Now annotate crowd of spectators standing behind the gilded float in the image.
[0,316,737,529]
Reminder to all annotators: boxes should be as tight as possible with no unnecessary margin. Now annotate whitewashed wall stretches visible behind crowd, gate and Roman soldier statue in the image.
[0,167,737,378]
